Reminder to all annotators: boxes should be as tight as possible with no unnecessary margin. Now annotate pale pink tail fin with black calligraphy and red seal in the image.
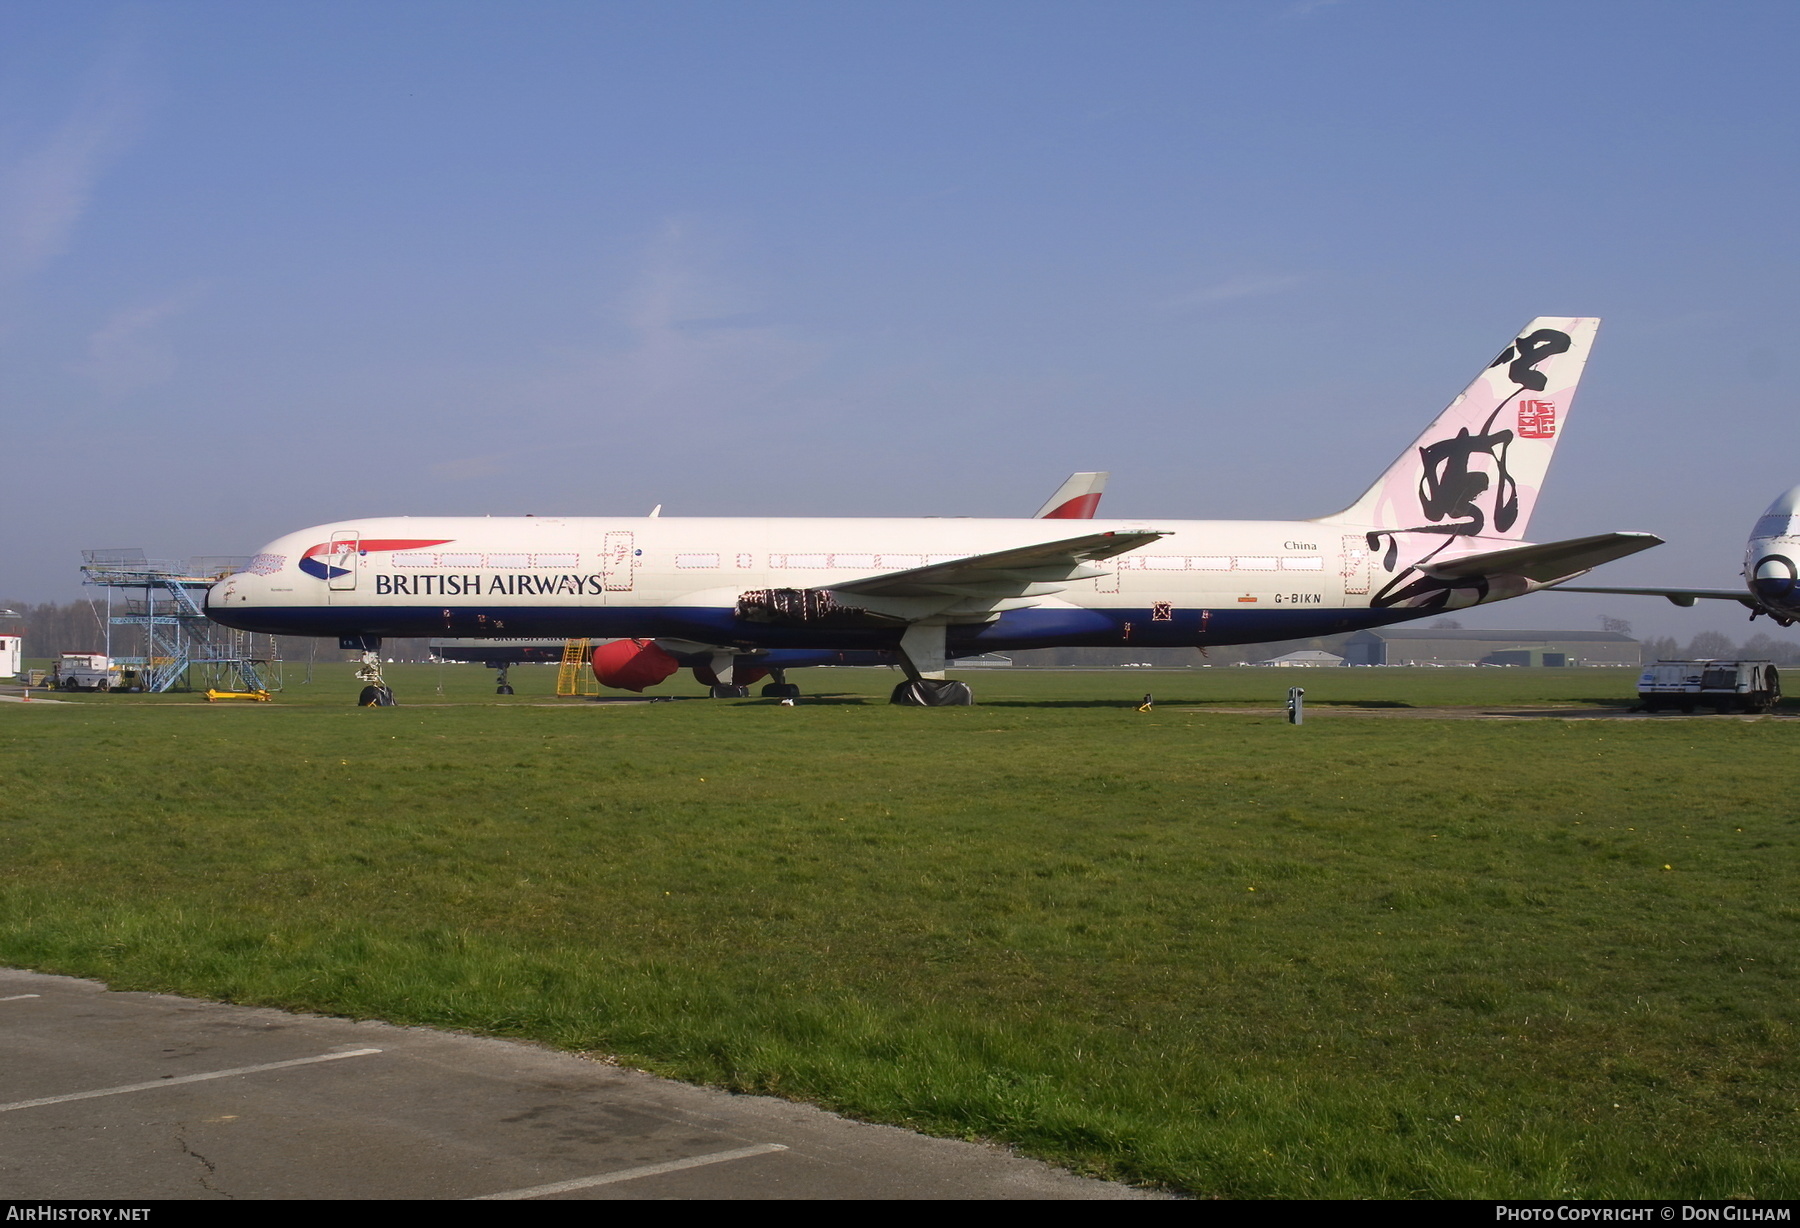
[1319,315,1600,540]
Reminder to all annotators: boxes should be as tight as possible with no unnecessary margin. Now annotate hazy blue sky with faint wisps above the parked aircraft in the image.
[0,0,1800,636]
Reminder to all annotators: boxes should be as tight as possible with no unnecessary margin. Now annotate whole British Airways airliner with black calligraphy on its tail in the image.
[207,317,1661,704]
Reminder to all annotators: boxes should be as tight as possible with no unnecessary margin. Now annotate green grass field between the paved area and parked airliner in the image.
[0,664,1800,1197]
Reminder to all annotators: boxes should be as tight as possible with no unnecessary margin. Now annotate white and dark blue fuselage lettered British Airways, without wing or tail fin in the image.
[207,517,1523,648]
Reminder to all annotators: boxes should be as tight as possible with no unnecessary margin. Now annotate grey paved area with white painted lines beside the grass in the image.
[0,969,1156,1199]
